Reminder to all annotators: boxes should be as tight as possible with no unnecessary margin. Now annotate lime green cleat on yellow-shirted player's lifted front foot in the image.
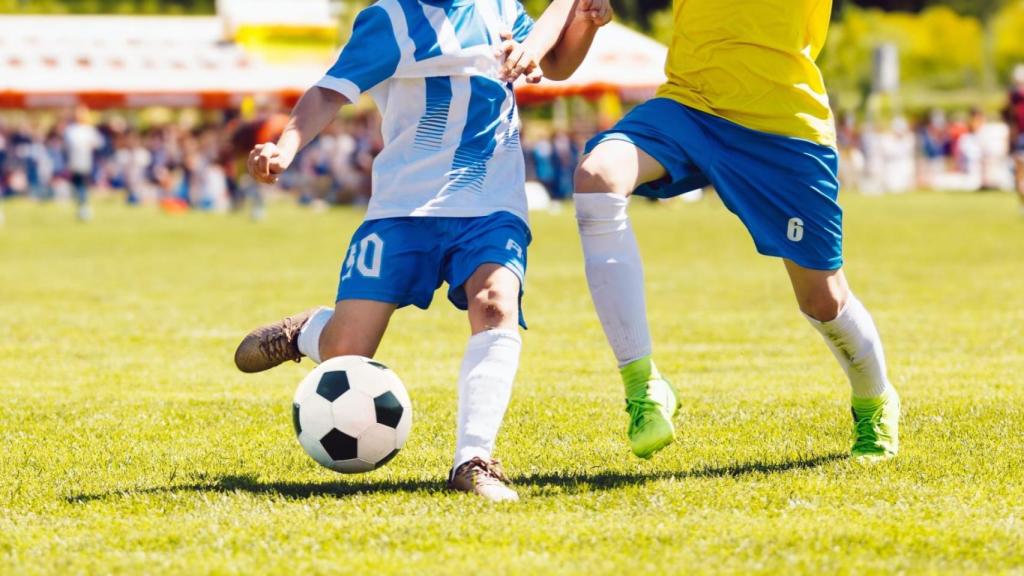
[620,356,679,459]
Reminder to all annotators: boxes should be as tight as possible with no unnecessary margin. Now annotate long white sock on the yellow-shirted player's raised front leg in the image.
[573,194,651,367]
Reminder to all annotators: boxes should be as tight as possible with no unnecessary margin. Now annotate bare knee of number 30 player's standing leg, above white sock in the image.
[465,262,521,334]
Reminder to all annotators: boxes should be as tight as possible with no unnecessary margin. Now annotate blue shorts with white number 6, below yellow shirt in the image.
[587,98,843,270]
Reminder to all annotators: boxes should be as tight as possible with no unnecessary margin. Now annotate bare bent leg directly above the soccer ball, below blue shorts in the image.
[319,299,396,360]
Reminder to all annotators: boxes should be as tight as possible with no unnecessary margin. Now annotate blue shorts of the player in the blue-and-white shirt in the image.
[336,212,531,328]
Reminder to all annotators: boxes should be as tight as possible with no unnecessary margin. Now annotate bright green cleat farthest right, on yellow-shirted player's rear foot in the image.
[850,387,900,460]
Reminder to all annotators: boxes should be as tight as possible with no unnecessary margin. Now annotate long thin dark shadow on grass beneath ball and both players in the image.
[65,453,848,503]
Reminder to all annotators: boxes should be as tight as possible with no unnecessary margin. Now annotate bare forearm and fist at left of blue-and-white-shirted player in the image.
[249,86,349,183]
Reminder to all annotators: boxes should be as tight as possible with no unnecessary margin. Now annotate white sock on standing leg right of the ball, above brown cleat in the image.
[455,329,522,468]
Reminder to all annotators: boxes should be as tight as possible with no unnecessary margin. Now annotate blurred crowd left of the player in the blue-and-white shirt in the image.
[0,108,382,219]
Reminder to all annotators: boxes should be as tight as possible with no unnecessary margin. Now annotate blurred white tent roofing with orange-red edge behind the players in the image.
[0,15,668,109]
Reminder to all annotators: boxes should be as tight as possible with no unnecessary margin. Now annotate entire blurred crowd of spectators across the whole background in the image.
[0,69,1024,219]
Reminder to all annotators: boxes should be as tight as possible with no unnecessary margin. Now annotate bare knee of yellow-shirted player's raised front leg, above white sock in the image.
[575,139,667,196]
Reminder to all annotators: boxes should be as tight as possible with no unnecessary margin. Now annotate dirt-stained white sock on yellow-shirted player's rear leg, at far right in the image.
[804,293,890,398]
